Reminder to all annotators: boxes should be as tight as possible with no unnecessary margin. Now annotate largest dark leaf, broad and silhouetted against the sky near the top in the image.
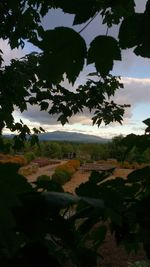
[36,27,86,83]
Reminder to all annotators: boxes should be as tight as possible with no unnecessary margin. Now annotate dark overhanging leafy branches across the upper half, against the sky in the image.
[0,0,140,147]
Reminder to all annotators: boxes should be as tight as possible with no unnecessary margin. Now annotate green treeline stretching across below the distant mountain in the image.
[2,135,150,163]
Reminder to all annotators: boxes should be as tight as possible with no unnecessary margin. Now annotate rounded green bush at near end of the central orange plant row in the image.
[52,170,72,185]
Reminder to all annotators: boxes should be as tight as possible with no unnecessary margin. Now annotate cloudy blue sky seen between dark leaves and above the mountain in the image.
[0,0,150,138]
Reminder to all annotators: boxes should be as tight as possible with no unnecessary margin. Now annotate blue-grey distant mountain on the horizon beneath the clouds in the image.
[39,131,110,143]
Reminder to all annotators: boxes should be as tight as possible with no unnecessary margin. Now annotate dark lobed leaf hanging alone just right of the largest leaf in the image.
[88,35,121,77]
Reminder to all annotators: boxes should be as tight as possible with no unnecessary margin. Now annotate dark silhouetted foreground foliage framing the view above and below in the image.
[0,0,150,266]
